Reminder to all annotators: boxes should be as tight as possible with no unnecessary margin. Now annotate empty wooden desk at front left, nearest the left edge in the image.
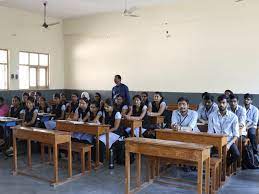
[12,126,72,186]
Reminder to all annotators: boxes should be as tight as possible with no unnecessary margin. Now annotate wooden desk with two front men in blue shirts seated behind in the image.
[156,129,227,181]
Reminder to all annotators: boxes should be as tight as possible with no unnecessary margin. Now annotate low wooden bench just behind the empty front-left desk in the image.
[41,142,92,175]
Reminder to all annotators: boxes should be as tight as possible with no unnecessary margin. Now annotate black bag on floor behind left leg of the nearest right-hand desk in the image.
[112,140,135,165]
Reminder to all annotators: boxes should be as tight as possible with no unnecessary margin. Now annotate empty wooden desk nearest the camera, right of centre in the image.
[125,137,212,194]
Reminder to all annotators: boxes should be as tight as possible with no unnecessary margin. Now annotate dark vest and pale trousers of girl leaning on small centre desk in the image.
[125,105,149,137]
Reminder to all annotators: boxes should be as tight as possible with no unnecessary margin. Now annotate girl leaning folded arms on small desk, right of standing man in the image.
[125,95,149,137]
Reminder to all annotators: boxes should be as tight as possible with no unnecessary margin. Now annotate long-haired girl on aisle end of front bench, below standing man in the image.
[99,98,123,161]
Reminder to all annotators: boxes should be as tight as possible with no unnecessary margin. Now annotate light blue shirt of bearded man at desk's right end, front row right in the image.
[208,110,239,142]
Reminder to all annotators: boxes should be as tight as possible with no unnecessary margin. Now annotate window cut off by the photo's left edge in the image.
[0,49,8,90]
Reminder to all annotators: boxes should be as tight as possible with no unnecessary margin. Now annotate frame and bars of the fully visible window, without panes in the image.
[19,50,50,90]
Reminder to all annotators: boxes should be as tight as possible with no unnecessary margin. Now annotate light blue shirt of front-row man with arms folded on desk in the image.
[171,109,199,131]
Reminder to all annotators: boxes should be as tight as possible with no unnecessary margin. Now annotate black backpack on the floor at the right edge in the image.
[242,143,259,169]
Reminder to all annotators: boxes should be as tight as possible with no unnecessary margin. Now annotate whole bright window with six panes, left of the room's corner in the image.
[19,51,49,89]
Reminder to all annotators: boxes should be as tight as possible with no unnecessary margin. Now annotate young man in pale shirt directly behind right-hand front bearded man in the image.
[228,94,247,139]
